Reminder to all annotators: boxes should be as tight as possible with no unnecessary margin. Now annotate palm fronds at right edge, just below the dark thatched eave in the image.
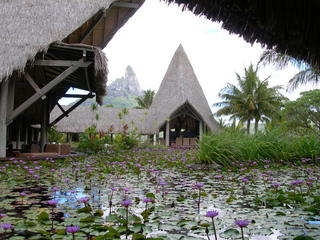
[258,49,320,91]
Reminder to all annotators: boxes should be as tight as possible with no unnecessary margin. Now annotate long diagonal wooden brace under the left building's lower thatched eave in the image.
[7,62,81,122]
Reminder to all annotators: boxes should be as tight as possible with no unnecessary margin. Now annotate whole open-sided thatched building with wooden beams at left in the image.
[0,0,144,157]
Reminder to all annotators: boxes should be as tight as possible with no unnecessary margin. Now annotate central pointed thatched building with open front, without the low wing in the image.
[149,45,218,146]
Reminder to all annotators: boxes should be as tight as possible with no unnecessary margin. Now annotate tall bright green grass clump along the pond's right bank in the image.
[198,130,320,167]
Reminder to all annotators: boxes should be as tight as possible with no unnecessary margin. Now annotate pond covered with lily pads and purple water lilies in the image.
[0,149,320,240]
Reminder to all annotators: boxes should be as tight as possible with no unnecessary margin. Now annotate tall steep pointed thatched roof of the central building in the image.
[150,44,219,131]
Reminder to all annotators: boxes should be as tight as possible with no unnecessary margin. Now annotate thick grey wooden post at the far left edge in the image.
[0,79,9,157]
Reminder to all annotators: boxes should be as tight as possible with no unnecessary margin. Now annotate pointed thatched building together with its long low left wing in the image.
[53,45,219,146]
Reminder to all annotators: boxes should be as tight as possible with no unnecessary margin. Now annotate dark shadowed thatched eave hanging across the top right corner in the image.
[164,0,320,67]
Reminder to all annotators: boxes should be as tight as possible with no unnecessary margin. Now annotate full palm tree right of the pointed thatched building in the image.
[214,64,283,134]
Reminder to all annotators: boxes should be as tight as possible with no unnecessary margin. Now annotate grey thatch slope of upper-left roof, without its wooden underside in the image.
[0,0,114,81]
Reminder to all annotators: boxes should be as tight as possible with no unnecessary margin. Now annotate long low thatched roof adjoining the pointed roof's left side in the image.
[51,106,155,134]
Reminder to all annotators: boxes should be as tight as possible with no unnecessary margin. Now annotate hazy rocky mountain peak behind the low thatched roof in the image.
[82,66,142,108]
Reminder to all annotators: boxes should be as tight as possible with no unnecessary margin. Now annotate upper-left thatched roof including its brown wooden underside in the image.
[0,0,144,82]
